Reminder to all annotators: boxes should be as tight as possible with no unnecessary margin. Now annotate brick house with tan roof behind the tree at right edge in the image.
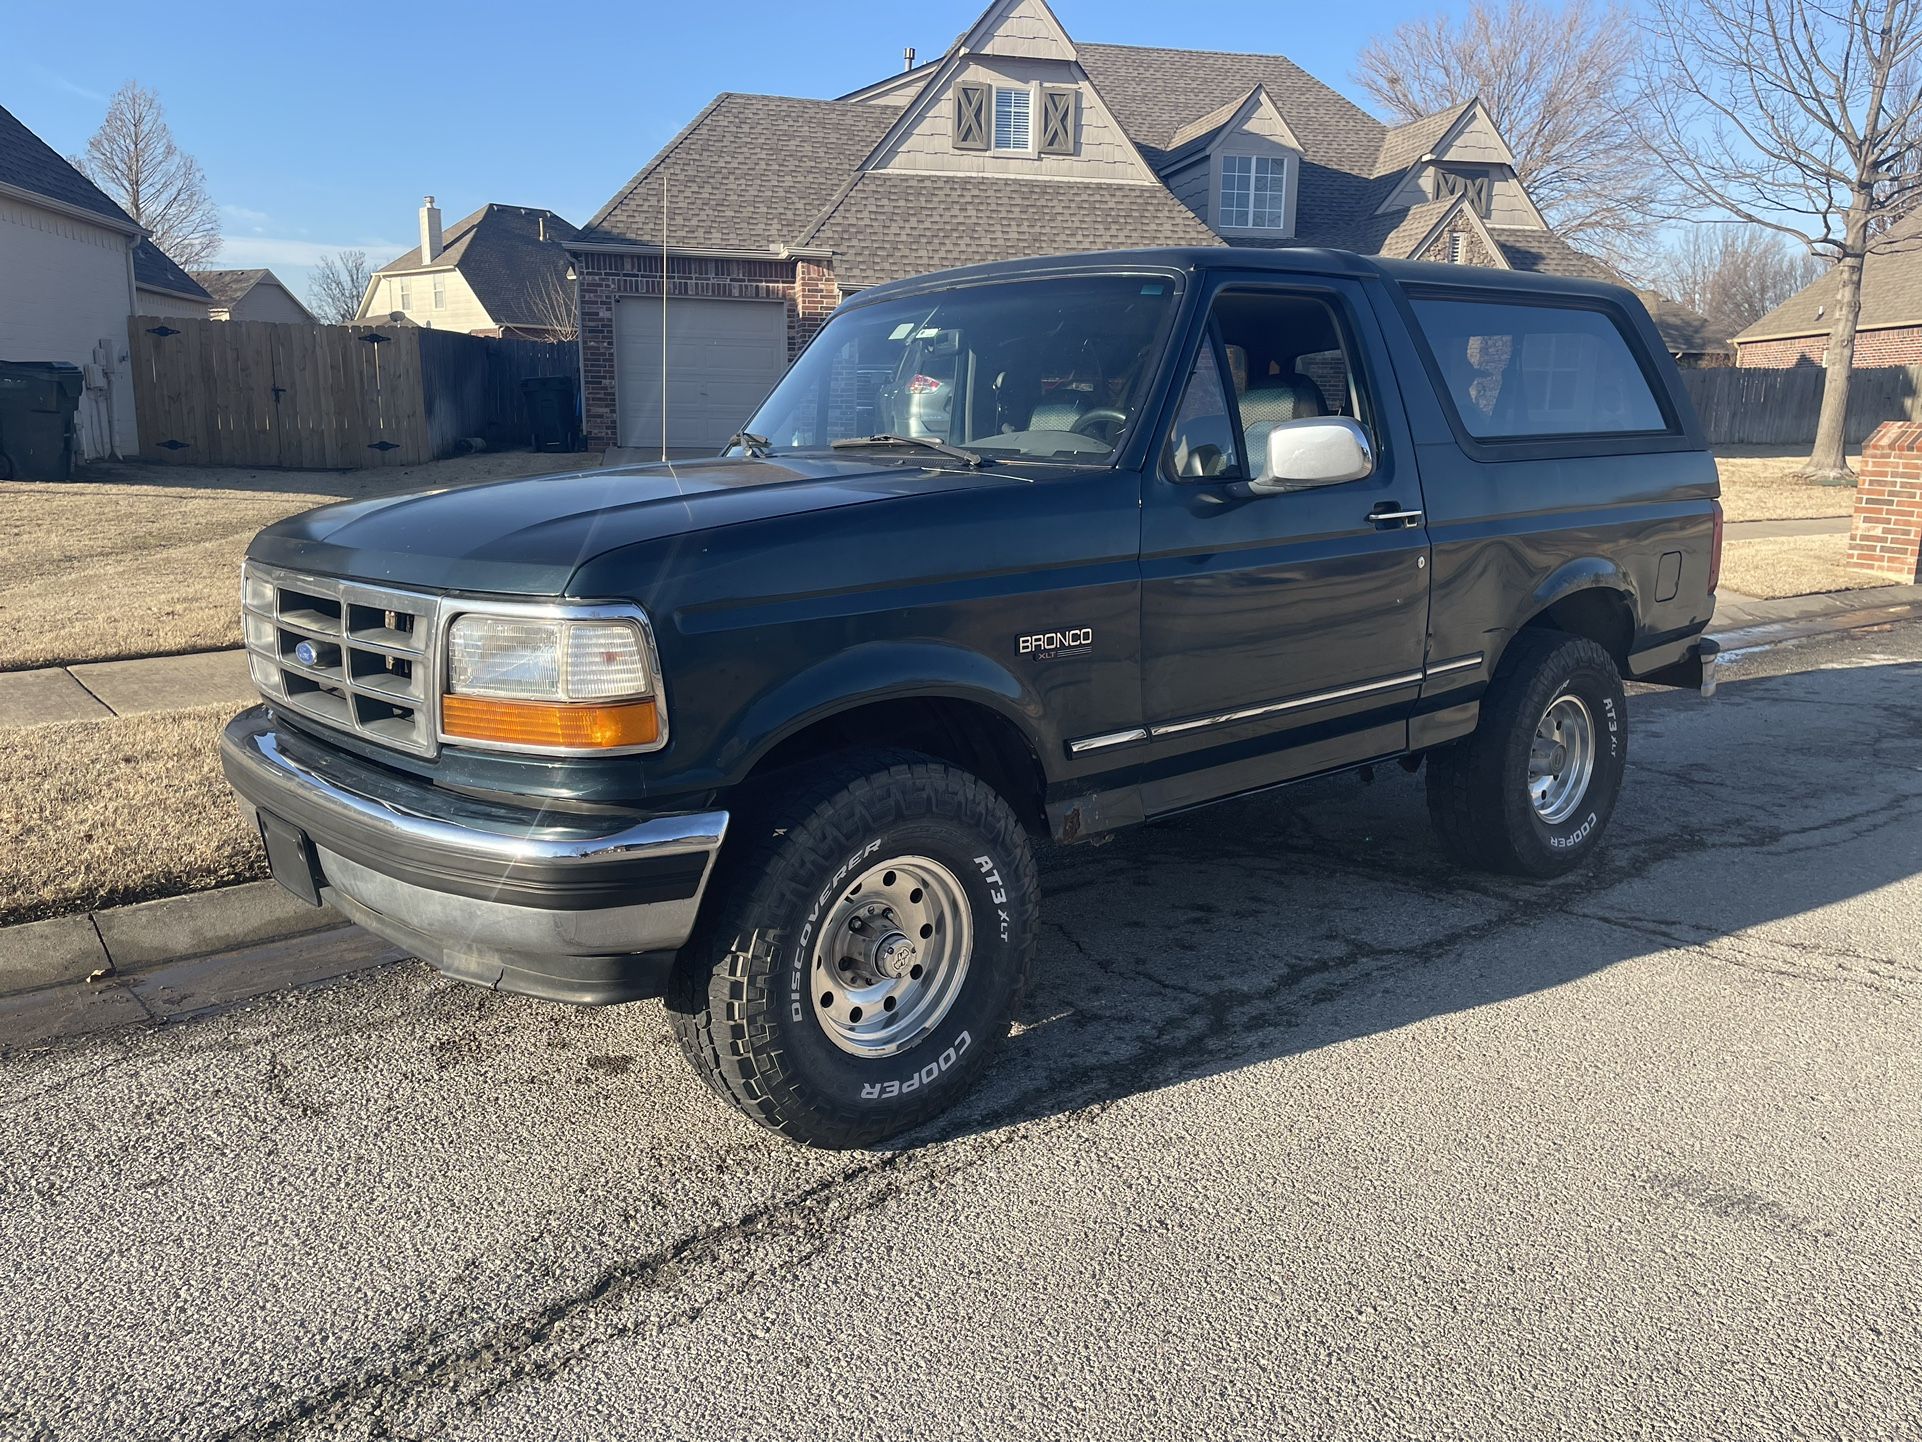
[1736,231,1922,369]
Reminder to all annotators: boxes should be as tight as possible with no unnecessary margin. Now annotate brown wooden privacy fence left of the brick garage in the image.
[129,315,579,471]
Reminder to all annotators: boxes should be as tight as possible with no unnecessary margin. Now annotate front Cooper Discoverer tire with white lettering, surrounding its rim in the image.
[667,750,1040,1148]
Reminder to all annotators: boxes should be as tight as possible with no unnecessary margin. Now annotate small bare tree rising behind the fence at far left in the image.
[73,81,221,271]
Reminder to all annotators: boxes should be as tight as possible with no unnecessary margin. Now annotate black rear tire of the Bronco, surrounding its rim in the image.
[1428,631,1628,877]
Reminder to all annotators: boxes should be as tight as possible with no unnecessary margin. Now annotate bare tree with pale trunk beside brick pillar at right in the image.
[1639,0,1922,483]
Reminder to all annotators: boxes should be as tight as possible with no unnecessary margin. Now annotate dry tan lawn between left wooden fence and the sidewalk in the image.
[0,452,598,671]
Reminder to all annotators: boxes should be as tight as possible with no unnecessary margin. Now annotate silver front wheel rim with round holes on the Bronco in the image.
[811,856,974,1057]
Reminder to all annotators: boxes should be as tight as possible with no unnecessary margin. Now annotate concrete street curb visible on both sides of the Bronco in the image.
[0,598,1922,1050]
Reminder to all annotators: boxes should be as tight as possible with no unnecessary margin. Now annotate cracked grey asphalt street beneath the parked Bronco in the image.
[0,625,1922,1442]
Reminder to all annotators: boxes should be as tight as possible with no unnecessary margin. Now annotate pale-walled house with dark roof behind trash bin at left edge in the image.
[0,108,142,460]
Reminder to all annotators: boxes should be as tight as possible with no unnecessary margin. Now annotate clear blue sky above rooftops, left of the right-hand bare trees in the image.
[0,0,1449,294]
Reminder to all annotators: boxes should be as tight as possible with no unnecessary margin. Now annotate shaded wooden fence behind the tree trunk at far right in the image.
[1682,365,1922,446]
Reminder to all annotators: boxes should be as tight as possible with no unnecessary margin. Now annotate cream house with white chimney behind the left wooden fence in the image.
[354,196,577,340]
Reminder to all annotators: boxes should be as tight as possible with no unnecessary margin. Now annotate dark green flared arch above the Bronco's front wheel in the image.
[715,640,1059,784]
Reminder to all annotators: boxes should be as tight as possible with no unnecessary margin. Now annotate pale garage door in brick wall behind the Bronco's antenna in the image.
[613,298,788,450]
